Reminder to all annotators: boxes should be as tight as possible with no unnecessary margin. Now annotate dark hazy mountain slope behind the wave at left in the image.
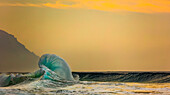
[0,30,39,72]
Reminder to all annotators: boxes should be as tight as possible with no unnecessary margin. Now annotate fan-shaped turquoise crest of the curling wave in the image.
[38,54,74,81]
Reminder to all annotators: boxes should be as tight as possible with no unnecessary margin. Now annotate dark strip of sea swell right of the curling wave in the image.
[73,71,170,83]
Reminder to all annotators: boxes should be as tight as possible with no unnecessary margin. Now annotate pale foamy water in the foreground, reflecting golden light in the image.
[0,80,170,95]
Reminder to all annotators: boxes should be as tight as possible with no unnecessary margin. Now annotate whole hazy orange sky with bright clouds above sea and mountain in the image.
[0,0,170,71]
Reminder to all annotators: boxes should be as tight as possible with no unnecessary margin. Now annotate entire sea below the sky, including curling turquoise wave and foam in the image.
[0,54,170,95]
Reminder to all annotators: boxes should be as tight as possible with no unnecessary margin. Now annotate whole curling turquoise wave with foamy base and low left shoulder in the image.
[0,54,78,87]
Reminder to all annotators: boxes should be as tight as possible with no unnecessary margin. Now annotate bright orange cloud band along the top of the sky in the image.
[0,0,170,13]
